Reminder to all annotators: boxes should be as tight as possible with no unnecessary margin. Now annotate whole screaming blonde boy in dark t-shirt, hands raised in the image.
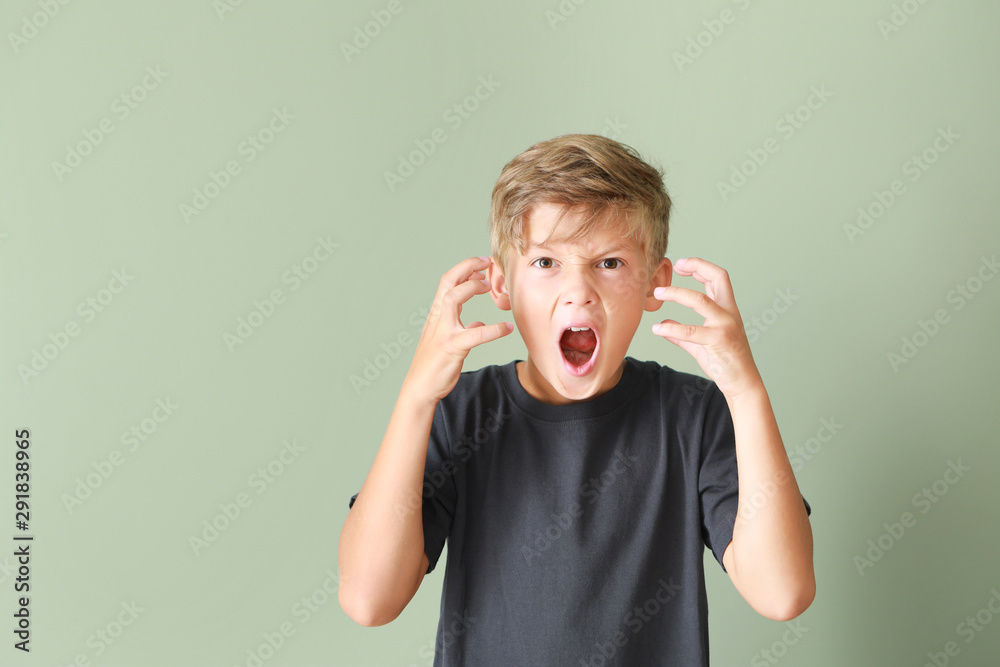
[338,135,815,667]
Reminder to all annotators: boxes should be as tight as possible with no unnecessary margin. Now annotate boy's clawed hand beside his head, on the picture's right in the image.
[653,257,764,399]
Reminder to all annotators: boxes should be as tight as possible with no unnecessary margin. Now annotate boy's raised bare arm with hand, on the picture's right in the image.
[653,257,816,620]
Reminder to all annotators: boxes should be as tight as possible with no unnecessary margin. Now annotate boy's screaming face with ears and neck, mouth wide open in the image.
[488,203,673,405]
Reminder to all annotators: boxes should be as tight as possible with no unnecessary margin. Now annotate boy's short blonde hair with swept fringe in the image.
[490,134,671,279]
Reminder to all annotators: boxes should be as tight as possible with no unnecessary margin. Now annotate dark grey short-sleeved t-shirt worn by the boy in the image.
[351,357,811,667]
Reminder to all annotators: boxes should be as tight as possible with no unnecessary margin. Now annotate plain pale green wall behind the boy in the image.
[0,0,1000,667]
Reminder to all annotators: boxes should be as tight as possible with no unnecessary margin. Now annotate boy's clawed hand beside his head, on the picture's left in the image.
[403,257,514,402]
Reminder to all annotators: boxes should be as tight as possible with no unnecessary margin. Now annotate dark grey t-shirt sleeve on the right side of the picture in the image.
[698,382,812,571]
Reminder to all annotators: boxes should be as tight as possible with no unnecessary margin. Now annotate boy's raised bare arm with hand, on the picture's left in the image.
[337,257,512,626]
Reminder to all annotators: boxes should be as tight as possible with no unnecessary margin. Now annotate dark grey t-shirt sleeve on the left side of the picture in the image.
[347,401,458,573]
